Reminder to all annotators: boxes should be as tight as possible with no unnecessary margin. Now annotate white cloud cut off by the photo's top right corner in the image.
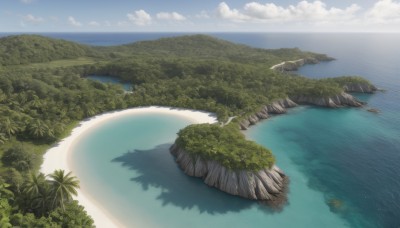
[365,0,400,24]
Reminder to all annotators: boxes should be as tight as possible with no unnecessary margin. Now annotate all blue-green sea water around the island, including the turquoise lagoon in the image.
[4,33,400,228]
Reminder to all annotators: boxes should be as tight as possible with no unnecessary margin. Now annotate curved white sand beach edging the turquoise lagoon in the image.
[40,106,217,228]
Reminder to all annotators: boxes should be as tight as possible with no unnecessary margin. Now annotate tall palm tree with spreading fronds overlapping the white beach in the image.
[49,170,79,210]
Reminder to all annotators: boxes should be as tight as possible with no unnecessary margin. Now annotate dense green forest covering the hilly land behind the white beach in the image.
[0,35,368,227]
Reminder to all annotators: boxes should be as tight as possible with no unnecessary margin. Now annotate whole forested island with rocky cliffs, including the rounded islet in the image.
[0,35,376,227]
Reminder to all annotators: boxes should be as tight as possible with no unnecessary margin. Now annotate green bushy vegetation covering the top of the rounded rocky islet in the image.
[175,124,275,171]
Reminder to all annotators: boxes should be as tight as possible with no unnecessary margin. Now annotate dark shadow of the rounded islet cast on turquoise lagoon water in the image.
[112,144,257,214]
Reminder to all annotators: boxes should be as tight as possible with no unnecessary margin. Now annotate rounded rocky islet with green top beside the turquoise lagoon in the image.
[171,124,287,201]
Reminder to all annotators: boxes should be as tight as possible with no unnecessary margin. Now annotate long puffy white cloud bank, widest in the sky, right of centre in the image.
[217,1,360,23]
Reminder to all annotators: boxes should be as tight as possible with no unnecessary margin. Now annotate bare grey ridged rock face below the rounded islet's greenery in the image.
[170,144,287,201]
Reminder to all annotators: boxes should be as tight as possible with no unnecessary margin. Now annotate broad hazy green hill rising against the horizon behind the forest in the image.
[108,35,330,66]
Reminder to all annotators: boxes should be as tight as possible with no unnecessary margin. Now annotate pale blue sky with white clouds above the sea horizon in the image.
[0,0,400,32]
